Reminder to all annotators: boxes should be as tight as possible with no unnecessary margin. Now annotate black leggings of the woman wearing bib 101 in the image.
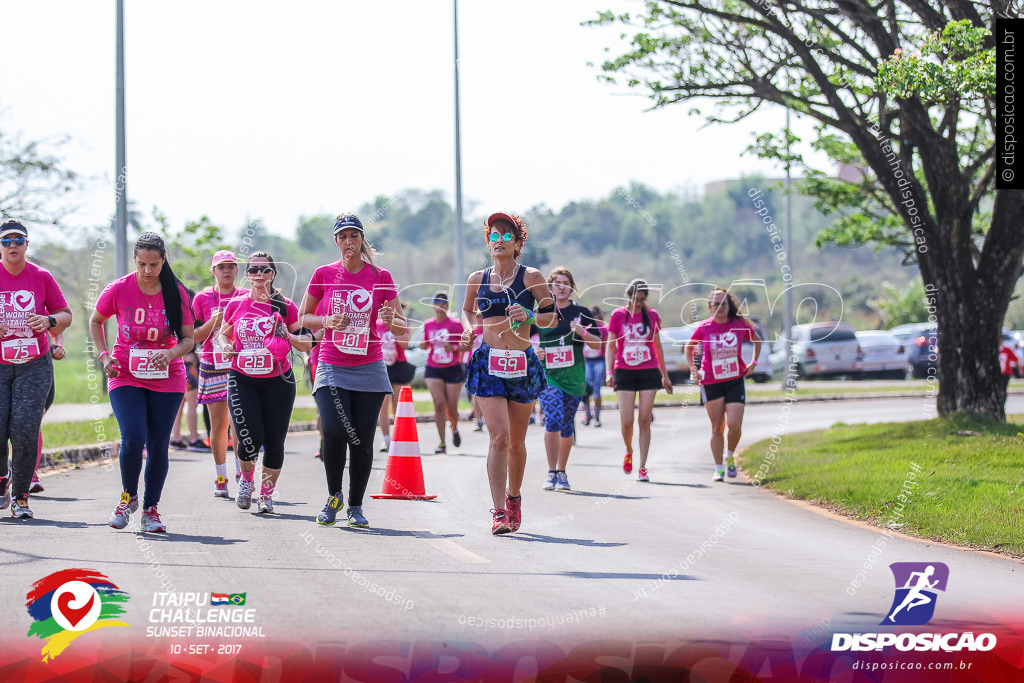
[313,386,387,506]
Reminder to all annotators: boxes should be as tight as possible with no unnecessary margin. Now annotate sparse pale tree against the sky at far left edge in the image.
[0,124,79,225]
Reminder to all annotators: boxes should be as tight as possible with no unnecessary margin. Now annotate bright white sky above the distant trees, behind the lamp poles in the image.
[0,0,783,233]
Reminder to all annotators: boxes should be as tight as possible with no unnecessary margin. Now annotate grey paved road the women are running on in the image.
[0,396,1024,643]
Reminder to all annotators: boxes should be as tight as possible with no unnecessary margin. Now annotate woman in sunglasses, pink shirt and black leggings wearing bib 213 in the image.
[220,251,313,513]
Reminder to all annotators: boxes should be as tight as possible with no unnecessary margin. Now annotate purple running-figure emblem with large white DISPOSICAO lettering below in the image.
[831,562,996,652]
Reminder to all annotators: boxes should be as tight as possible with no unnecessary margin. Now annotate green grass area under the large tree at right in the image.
[740,416,1024,557]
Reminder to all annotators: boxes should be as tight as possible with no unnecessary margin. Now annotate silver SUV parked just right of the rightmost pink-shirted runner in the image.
[771,322,863,378]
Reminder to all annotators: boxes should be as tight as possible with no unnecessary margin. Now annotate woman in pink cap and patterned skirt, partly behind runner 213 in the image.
[193,250,249,498]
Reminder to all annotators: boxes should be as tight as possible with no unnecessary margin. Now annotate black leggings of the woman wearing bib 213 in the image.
[227,370,295,470]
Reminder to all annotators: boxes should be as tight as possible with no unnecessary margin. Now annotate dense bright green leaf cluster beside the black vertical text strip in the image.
[874,19,995,103]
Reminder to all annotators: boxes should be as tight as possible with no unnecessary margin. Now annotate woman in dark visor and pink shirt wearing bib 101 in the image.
[299,213,407,527]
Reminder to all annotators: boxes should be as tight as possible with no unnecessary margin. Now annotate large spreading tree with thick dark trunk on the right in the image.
[592,0,1024,420]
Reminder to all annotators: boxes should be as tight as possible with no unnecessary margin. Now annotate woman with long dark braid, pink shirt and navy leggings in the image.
[89,232,196,532]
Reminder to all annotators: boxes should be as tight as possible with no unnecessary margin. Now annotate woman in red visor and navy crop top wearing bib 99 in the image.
[462,213,558,536]
